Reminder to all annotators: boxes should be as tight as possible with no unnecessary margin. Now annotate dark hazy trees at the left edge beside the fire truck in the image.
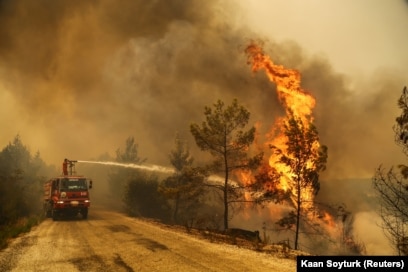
[0,135,55,248]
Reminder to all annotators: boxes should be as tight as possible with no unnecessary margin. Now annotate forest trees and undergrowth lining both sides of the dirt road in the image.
[0,88,408,255]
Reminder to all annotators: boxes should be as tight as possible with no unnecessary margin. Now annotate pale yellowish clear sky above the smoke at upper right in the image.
[242,0,408,76]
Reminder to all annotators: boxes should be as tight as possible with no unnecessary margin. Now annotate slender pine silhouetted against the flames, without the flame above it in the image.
[271,114,327,249]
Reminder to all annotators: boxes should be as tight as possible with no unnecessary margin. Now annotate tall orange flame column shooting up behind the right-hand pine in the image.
[245,43,320,208]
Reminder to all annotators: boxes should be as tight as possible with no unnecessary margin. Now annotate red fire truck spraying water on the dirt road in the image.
[44,159,92,221]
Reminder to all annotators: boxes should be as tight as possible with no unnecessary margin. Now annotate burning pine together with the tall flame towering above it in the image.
[245,43,327,249]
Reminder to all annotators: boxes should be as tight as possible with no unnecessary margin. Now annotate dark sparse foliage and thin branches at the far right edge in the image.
[372,87,408,255]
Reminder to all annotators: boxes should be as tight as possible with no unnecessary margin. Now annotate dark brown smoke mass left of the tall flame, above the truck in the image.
[0,0,277,166]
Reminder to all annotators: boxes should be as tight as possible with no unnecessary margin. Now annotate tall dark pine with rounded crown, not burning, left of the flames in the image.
[190,99,263,229]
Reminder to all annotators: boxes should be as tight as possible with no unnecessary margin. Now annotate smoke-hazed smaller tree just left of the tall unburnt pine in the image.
[159,134,204,224]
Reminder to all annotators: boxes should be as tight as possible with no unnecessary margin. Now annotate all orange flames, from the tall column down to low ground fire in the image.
[241,42,344,250]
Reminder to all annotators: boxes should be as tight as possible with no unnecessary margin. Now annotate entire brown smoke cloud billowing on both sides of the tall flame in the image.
[0,0,406,255]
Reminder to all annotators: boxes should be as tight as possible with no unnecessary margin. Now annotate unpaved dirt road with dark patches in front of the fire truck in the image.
[0,208,296,272]
